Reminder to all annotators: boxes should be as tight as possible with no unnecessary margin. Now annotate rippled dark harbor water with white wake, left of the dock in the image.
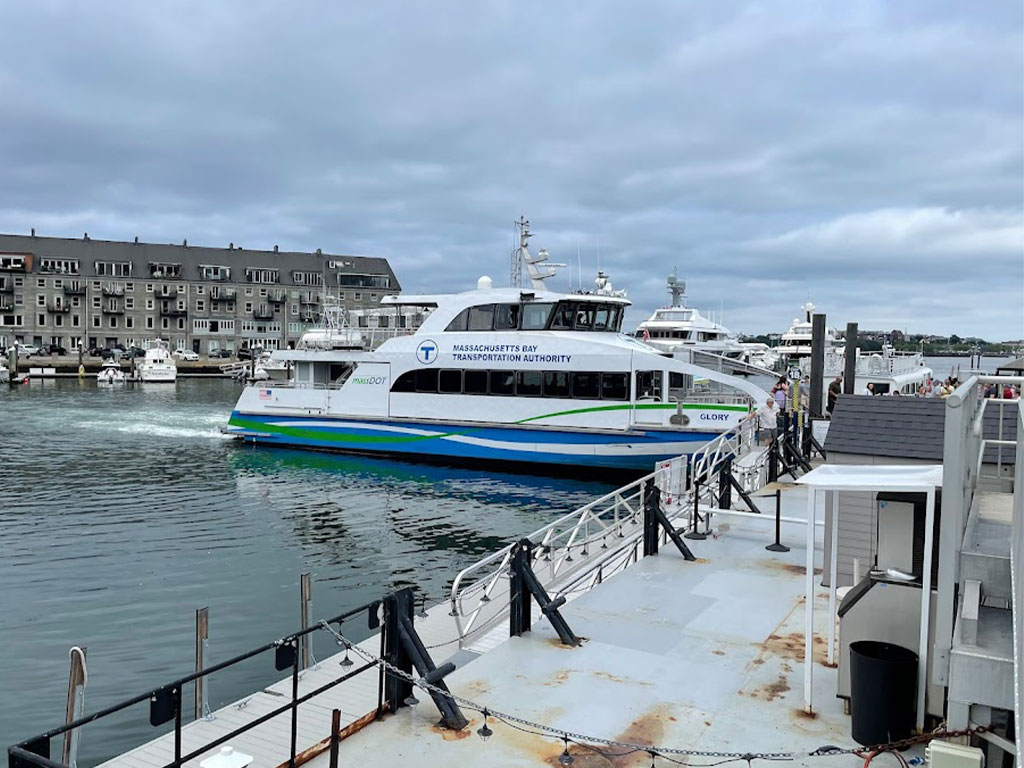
[0,379,613,765]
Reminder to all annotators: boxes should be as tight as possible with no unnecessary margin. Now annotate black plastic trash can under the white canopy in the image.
[850,640,918,746]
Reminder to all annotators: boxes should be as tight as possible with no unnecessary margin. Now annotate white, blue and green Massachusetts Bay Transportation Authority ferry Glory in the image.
[225,224,767,470]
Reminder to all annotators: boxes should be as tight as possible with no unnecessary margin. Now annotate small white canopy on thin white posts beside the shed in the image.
[797,464,942,730]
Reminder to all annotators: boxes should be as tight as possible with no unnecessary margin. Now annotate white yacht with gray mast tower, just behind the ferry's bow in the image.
[635,270,745,358]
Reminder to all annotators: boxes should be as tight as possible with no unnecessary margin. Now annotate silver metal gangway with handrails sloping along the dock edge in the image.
[450,418,776,647]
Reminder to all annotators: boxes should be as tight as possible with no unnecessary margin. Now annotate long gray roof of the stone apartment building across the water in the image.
[0,234,400,289]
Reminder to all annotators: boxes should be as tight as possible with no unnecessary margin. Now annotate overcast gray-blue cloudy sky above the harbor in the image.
[0,0,1024,340]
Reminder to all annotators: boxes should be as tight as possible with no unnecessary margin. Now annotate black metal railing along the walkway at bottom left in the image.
[7,598,387,768]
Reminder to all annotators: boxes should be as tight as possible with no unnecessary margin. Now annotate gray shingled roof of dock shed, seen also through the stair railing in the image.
[824,394,1017,464]
